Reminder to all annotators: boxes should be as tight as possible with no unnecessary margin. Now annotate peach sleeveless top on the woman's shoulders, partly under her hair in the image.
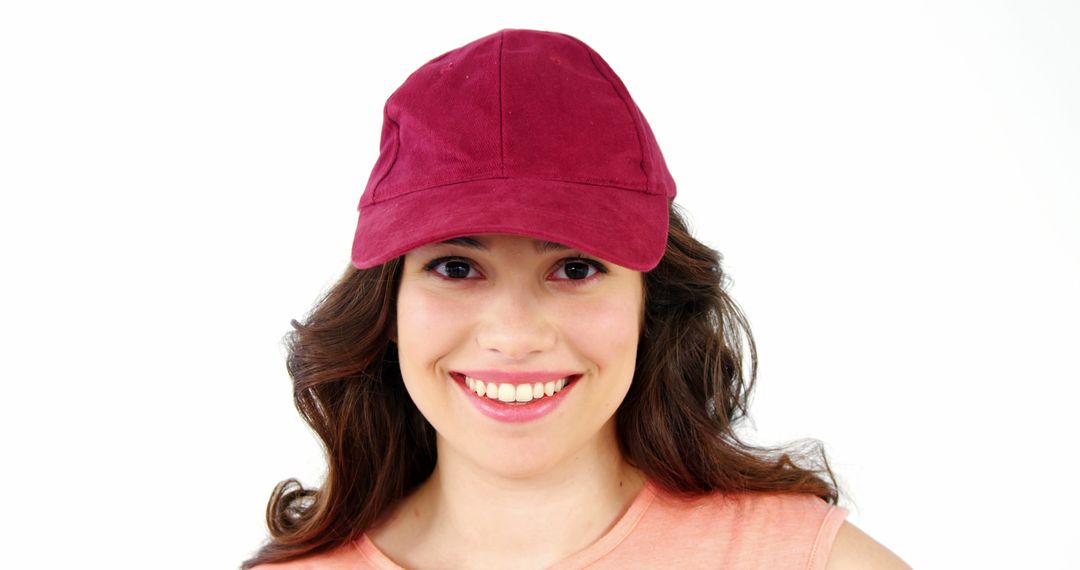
[250,483,848,570]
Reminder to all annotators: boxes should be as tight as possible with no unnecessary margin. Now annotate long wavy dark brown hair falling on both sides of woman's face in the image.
[242,204,839,569]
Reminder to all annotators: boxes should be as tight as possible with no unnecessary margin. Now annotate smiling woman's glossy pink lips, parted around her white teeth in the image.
[451,370,581,423]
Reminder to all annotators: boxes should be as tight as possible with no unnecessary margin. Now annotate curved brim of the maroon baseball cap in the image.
[352,178,669,272]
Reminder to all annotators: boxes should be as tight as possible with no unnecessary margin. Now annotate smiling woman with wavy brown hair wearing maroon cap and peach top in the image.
[244,29,906,568]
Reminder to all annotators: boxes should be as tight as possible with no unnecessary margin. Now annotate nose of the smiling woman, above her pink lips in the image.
[476,284,558,361]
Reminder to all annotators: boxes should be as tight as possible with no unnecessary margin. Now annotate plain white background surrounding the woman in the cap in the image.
[0,0,1080,568]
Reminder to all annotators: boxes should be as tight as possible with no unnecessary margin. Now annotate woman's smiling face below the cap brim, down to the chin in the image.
[396,234,644,476]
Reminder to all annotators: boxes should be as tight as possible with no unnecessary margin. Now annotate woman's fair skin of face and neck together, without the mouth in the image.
[368,234,645,568]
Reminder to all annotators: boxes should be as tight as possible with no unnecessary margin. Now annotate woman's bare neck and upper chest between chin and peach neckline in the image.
[369,424,645,568]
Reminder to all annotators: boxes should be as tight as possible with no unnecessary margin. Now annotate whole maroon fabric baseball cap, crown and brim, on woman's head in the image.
[352,29,675,271]
